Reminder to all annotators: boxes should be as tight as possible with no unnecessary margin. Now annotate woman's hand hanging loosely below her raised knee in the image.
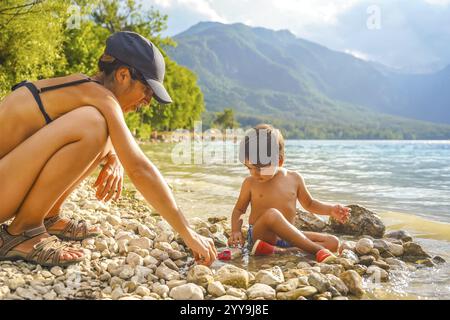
[94,154,123,202]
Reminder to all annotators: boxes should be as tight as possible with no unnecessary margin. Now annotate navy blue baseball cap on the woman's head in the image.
[105,31,172,104]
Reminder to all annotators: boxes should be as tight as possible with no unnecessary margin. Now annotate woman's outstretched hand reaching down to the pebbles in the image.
[183,228,217,266]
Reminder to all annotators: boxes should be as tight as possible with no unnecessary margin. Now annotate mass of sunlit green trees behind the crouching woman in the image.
[0,0,205,138]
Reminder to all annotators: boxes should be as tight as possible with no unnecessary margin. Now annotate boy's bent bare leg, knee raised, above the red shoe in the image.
[253,209,324,254]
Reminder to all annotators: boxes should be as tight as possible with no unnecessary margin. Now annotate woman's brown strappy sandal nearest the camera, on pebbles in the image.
[0,224,84,267]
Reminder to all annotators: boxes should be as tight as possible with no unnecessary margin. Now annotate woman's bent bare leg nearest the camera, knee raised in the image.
[0,107,107,259]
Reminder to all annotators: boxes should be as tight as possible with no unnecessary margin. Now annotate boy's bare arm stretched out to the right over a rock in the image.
[296,173,350,223]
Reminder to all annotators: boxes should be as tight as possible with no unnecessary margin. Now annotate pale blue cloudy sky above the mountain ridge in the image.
[147,0,450,72]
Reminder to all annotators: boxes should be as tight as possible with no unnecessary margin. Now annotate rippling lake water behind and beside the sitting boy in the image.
[132,140,450,299]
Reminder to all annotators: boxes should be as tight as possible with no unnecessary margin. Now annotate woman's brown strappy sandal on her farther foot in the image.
[44,215,102,241]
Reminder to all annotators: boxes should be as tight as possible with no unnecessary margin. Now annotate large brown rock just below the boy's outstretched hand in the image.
[330,205,386,238]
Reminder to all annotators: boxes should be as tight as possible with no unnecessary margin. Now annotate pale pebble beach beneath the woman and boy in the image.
[0,179,448,300]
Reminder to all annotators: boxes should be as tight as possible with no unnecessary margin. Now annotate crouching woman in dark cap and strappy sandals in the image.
[0,32,217,266]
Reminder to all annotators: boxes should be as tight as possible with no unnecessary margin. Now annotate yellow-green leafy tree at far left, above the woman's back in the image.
[0,0,69,98]
